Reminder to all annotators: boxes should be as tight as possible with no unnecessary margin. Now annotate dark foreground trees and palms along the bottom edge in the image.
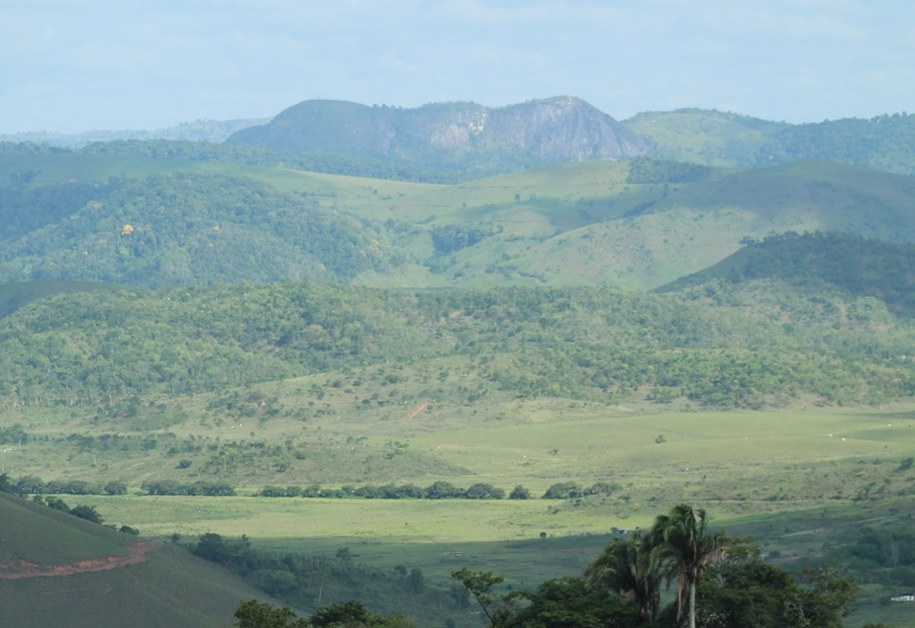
[218,504,857,628]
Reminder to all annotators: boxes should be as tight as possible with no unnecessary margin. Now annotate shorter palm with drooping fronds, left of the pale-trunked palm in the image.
[584,532,661,624]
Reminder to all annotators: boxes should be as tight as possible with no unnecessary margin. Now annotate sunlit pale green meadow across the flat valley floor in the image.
[60,408,915,544]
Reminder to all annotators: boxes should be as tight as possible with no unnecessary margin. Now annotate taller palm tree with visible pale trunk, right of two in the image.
[651,504,730,628]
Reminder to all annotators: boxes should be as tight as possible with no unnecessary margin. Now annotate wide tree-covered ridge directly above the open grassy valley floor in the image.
[0,280,915,408]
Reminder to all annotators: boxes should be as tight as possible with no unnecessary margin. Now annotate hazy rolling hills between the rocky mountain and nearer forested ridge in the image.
[0,139,915,289]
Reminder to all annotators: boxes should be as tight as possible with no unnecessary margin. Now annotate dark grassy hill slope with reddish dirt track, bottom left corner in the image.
[0,493,263,628]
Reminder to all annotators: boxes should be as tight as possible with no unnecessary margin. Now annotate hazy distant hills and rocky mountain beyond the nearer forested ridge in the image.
[0,97,915,289]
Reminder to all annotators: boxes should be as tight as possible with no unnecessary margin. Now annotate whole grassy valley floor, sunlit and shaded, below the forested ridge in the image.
[0,382,915,626]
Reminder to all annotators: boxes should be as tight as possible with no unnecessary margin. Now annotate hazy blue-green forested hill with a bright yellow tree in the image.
[0,174,385,286]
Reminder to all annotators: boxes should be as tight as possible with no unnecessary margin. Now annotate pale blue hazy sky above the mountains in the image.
[0,0,915,133]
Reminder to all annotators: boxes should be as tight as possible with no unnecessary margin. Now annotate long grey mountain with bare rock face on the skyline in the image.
[228,96,646,166]
